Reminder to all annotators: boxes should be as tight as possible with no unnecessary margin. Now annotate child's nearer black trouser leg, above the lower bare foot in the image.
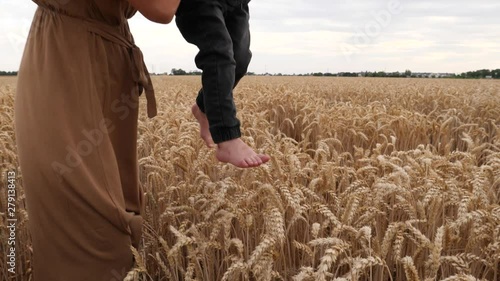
[176,0,241,143]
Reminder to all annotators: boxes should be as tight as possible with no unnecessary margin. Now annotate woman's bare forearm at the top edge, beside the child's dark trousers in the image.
[129,0,180,24]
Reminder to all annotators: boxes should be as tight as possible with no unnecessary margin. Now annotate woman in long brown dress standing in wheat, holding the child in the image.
[15,0,179,281]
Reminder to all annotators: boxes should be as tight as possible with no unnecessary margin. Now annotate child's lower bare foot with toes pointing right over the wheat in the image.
[215,138,270,168]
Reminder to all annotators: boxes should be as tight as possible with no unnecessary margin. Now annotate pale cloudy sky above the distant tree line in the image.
[0,0,500,74]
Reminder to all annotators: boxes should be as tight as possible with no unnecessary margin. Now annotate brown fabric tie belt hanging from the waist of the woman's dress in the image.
[41,8,157,118]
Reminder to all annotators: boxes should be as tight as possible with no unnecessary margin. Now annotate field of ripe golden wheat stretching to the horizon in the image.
[0,76,500,281]
